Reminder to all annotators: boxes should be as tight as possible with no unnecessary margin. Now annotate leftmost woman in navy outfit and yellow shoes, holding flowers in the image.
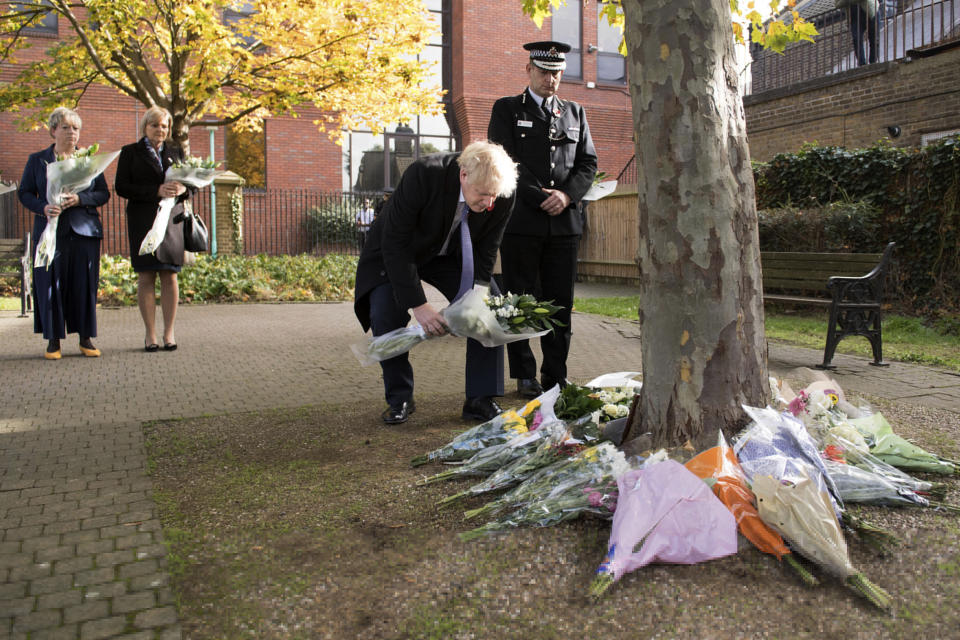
[17,107,110,360]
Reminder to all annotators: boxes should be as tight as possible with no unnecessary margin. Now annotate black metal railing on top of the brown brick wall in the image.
[747,0,960,94]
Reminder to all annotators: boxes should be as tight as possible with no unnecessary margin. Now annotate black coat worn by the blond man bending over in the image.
[354,153,514,331]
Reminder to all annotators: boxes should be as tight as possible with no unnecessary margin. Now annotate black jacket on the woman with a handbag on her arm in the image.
[114,139,195,270]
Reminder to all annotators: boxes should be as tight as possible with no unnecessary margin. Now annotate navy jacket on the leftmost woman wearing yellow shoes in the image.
[17,145,110,243]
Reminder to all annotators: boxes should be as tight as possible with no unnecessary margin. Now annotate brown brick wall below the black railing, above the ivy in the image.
[744,47,960,161]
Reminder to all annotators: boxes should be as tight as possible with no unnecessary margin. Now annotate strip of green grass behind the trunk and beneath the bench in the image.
[574,296,960,371]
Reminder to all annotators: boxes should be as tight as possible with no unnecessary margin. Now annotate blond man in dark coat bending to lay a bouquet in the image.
[354,142,517,424]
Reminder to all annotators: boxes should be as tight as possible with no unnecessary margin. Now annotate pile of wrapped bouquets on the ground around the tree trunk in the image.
[412,372,960,611]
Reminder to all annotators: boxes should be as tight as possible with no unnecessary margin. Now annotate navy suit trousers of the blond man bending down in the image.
[369,255,503,406]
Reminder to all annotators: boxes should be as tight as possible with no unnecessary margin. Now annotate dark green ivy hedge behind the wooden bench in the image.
[754,136,960,314]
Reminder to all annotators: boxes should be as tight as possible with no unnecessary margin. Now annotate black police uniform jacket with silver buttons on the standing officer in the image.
[487,89,597,236]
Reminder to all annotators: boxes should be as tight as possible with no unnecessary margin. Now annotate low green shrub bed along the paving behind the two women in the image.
[98,254,357,306]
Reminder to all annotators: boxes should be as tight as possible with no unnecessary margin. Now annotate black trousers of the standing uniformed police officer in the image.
[500,233,580,384]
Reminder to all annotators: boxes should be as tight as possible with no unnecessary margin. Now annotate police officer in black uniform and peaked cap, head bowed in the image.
[487,42,597,398]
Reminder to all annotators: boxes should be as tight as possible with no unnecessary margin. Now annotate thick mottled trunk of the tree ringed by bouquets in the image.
[623,0,768,446]
